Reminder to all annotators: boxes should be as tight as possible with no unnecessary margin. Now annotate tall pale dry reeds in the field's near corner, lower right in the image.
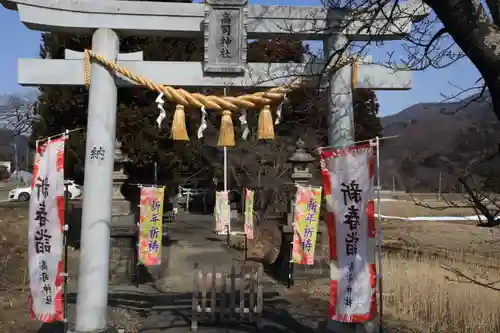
[382,250,500,333]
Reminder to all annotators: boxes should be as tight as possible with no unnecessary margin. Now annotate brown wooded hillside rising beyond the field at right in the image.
[381,92,500,191]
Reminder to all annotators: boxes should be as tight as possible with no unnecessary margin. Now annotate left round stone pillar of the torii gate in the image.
[75,28,119,332]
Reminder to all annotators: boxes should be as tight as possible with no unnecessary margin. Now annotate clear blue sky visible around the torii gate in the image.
[0,0,480,116]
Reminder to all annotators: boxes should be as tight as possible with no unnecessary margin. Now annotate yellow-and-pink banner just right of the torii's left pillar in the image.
[138,186,165,266]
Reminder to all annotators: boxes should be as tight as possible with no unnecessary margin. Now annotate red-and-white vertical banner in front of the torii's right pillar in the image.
[321,145,377,323]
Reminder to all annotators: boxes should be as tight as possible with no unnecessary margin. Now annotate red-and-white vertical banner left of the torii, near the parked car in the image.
[28,137,66,323]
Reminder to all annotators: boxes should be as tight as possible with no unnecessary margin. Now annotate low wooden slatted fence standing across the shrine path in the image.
[191,264,263,331]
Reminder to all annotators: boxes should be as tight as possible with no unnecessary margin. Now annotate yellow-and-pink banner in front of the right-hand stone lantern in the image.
[292,185,321,265]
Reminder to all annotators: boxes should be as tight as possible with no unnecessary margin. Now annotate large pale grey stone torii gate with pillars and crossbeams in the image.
[0,0,428,332]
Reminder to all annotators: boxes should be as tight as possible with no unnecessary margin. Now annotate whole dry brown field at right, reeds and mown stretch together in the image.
[374,198,500,333]
